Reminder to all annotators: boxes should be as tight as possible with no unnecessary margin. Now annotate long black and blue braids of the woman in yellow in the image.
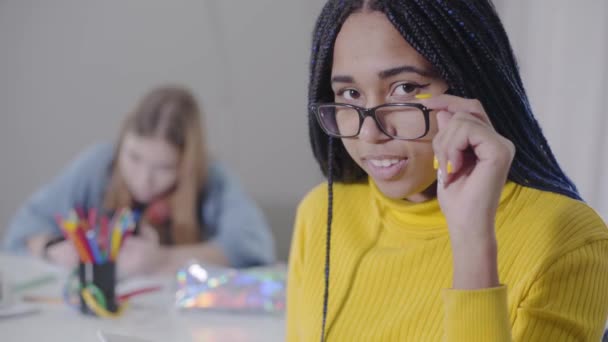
[308,0,581,341]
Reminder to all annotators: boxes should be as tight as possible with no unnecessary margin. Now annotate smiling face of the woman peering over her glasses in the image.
[332,12,447,202]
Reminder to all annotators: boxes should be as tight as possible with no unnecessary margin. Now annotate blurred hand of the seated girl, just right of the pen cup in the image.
[117,225,169,278]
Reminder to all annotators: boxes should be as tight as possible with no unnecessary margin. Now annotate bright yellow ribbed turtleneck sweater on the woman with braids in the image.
[287,182,608,342]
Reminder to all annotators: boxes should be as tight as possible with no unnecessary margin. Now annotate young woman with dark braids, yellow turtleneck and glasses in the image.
[287,0,608,341]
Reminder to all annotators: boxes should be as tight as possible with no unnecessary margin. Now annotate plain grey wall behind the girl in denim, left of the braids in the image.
[0,0,322,256]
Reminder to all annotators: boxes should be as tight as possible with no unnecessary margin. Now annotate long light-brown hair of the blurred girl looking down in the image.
[104,86,208,244]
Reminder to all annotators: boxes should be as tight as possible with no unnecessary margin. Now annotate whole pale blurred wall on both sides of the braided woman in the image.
[0,0,608,260]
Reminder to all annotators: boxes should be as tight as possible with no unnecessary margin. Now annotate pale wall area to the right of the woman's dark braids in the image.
[495,0,608,220]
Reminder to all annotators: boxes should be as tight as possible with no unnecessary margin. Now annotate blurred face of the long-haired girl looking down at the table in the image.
[118,133,179,203]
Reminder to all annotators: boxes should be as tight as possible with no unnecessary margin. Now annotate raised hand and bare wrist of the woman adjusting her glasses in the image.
[422,95,515,288]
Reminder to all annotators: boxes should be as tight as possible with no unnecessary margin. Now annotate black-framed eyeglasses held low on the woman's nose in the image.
[311,103,431,140]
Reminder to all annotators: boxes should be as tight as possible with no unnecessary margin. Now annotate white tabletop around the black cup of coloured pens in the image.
[0,254,285,342]
